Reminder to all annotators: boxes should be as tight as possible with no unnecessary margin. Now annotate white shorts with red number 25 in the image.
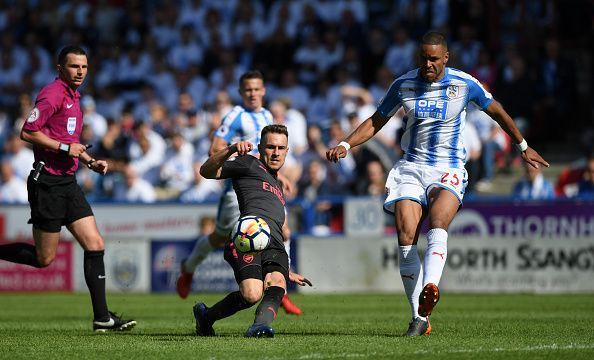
[384,159,468,214]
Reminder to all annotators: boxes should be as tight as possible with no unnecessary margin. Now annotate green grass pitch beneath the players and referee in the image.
[0,294,594,360]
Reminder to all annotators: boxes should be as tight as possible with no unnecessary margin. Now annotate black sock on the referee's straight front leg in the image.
[84,250,109,321]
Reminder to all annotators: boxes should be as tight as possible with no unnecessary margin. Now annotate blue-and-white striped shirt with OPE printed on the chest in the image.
[377,68,493,168]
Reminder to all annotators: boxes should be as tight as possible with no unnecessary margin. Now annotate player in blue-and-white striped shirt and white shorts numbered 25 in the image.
[326,32,549,336]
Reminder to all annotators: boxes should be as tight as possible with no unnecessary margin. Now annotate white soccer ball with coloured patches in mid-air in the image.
[231,215,270,254]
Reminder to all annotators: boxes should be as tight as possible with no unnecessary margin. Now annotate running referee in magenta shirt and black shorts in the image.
[0,46,136,332]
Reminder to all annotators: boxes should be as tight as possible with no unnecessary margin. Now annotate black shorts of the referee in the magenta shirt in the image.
[27,173,93,232]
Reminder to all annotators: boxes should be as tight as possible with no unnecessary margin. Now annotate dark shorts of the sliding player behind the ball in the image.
[224,241,289,284]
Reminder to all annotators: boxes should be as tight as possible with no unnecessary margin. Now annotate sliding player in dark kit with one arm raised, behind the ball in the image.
[194,125,311,337]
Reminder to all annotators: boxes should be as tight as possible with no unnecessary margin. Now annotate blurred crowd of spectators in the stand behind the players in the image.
[0,0,592,210]
